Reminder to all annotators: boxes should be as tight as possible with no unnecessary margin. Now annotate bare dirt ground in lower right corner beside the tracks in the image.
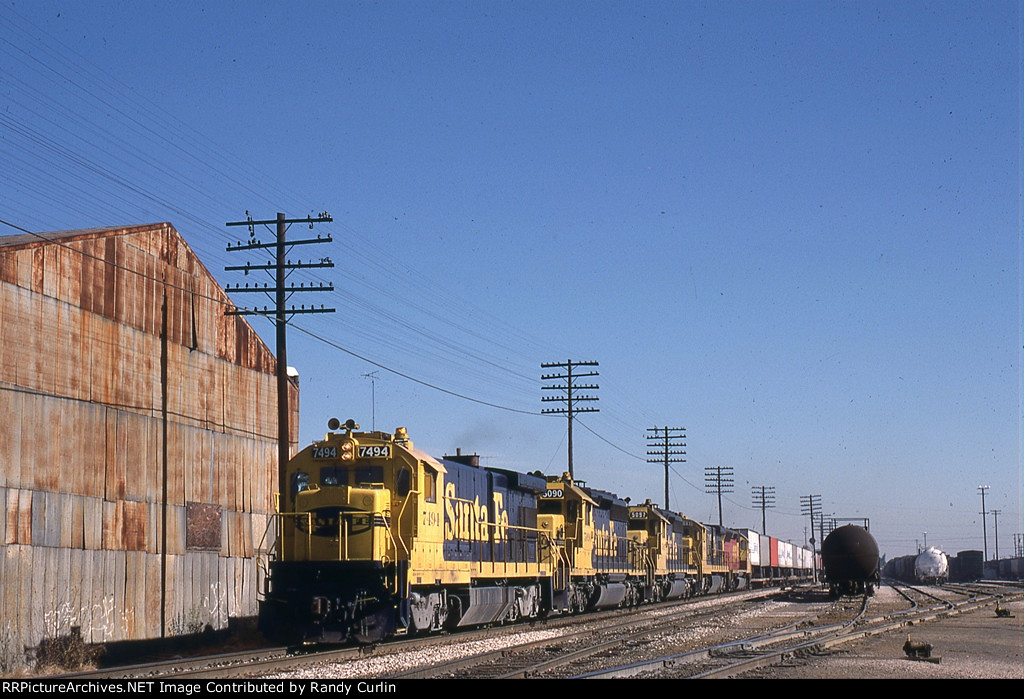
[748,589,1024,680]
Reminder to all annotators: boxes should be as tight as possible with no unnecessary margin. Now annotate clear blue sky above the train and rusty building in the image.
[0,0,1024,556]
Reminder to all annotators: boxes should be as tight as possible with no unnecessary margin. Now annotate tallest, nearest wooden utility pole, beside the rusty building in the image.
[224,211,335,493]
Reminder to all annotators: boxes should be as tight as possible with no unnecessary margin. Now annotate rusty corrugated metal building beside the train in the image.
[0,223,298,667]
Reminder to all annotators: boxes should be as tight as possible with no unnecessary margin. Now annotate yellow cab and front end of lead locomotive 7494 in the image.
[260,421,428,643]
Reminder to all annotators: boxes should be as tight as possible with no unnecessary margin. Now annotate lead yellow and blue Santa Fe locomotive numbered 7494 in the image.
[260,420,551,643]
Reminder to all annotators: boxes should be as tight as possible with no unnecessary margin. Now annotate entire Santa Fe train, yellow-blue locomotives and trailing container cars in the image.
[260,420,815,643]
